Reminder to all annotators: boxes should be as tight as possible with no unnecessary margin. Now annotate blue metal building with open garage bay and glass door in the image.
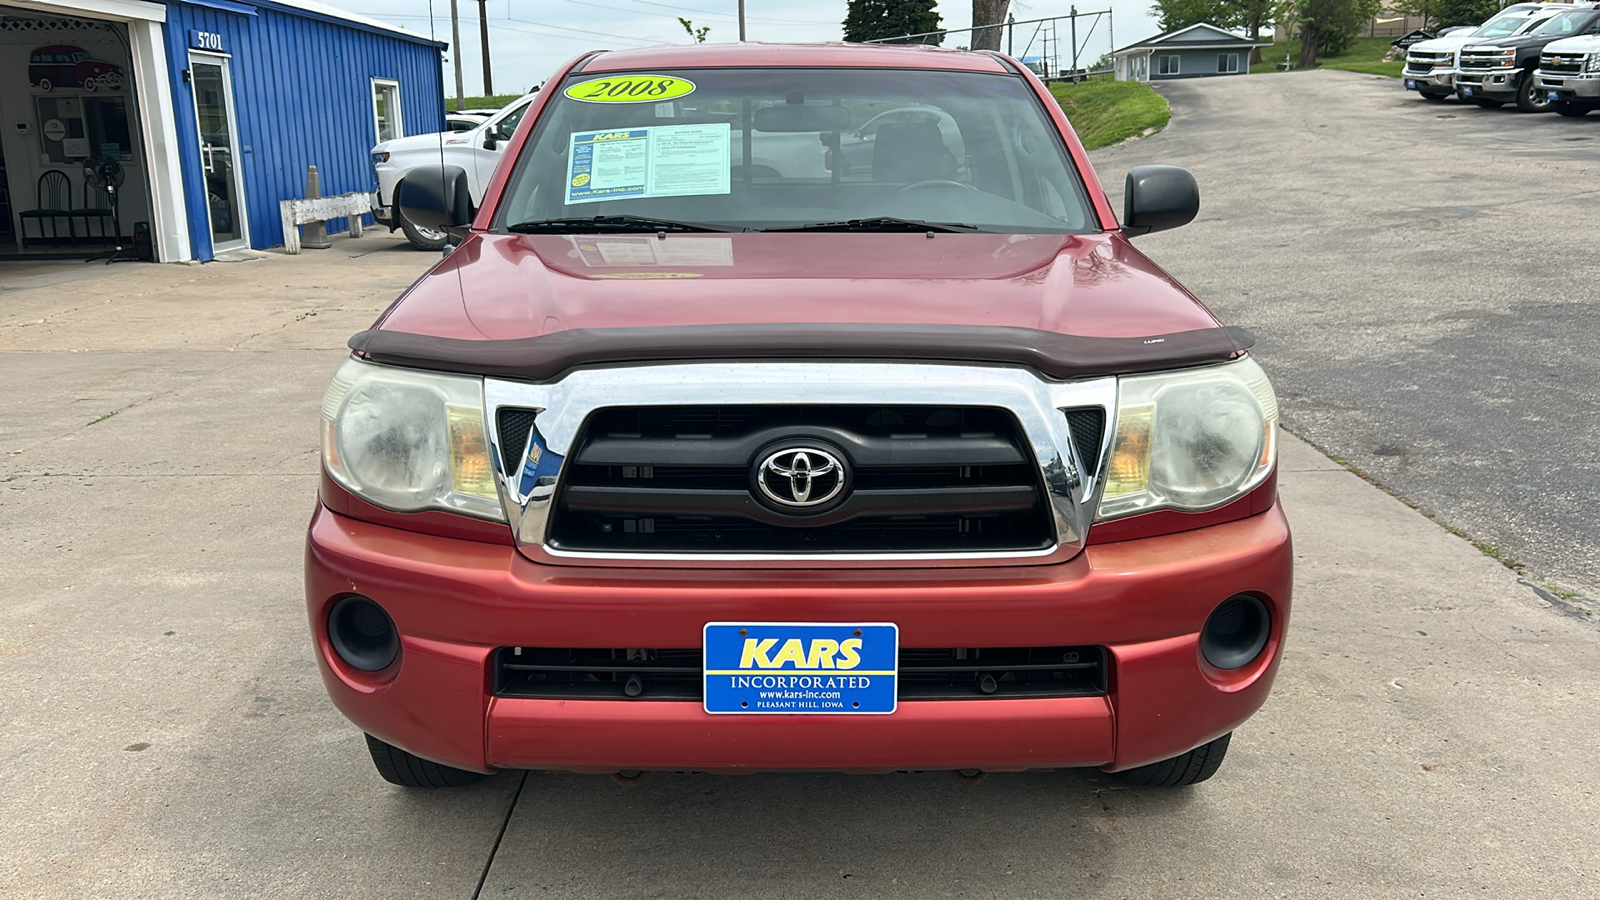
[0,0,446,261]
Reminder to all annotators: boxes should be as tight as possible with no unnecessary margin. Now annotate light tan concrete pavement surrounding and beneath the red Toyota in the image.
[0,235,1600,898]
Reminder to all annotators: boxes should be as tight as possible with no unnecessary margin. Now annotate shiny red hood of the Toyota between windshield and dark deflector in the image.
[374,232,1219,341]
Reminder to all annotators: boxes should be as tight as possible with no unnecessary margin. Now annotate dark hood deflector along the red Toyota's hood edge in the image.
[350,322,1256,381]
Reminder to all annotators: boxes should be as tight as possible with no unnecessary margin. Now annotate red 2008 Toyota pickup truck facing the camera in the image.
[306,43,1291,786]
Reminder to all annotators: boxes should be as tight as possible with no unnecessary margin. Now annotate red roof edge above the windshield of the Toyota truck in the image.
[582,42,1011,74]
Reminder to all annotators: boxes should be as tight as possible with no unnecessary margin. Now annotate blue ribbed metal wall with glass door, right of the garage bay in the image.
[166,0,445,259]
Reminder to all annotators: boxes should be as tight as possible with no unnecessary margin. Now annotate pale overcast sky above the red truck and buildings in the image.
[322,0,1158,96]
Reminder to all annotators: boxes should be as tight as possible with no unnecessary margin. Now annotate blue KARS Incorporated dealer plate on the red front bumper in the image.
[704,621,899,716]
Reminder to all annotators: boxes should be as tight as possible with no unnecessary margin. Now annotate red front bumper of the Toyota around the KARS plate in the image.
[306,504,1293,772]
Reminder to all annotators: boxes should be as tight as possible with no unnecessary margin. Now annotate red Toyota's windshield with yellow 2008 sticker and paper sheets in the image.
[496,69,1099,232]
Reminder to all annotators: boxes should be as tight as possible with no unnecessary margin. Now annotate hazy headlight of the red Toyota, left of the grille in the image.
[322,359,506,522]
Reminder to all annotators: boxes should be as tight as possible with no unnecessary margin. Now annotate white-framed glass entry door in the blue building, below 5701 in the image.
[189,53,250,253]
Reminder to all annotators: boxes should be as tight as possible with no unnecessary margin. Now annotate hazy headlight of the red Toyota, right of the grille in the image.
[1096,357,1278,520]
